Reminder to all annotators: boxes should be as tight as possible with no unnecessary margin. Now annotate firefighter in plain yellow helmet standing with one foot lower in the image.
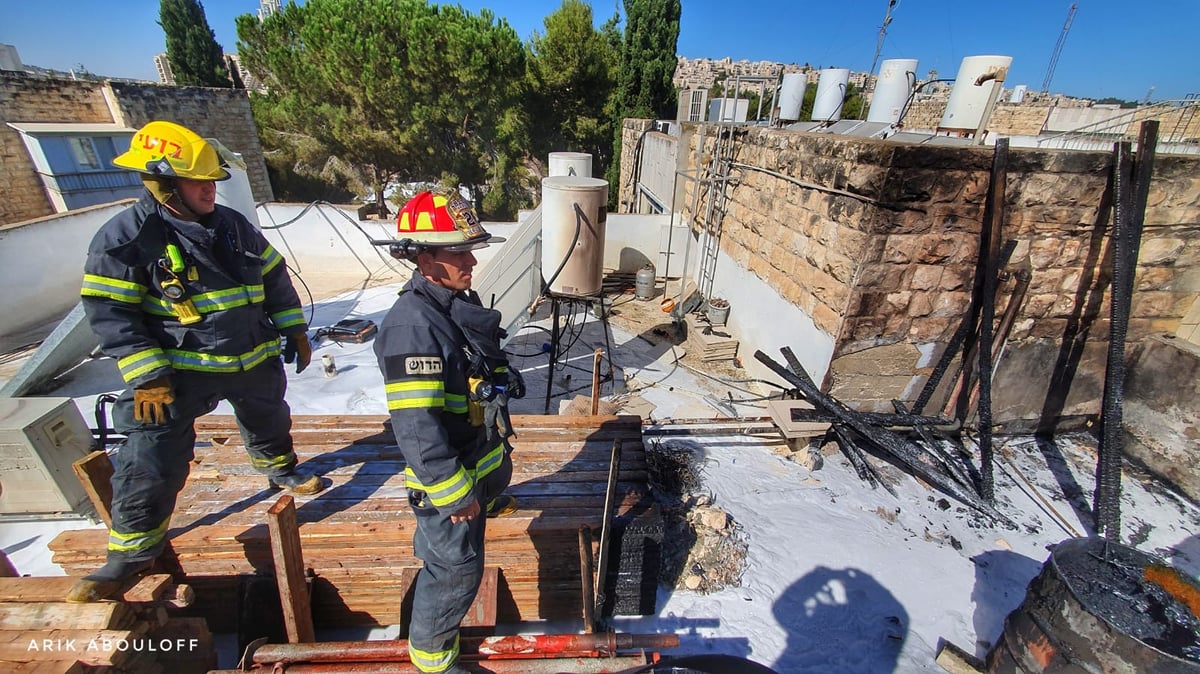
[67,121,323,602]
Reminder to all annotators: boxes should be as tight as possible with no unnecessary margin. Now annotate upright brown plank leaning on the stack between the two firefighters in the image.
[266,494,317,644]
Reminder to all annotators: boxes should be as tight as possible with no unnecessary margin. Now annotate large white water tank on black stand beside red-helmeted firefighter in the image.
[541,176,608,297]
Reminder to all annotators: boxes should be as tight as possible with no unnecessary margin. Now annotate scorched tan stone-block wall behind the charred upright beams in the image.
[622,118,1200,425]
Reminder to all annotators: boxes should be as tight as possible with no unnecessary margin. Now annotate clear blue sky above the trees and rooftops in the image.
[0,0,1200,101]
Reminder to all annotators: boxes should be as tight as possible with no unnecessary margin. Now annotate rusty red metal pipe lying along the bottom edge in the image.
[253,633,679,664]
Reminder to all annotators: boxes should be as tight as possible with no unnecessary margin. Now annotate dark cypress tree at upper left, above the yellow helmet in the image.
[158,0,233,89]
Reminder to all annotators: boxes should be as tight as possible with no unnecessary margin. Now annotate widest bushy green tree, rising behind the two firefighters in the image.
[236,0,528,216]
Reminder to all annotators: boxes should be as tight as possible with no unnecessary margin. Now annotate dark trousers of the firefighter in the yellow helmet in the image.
[108,357,296,562]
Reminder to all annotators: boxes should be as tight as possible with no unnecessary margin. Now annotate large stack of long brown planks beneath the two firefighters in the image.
[50,415,662,631]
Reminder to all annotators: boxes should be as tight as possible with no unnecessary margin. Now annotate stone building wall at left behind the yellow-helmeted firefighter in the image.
[0,74,274,224]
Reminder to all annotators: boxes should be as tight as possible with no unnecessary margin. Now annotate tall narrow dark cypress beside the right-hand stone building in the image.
[605,0,683,209]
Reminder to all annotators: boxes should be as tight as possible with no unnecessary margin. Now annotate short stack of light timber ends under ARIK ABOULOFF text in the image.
[0,574,217,674]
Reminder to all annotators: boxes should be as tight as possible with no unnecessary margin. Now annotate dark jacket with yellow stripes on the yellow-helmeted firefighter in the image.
[80,192,308,386]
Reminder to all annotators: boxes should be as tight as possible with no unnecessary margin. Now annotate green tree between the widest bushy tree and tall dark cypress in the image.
[526,0,620,177]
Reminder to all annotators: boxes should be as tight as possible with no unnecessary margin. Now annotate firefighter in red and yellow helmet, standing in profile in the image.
[374,192,524,673]
